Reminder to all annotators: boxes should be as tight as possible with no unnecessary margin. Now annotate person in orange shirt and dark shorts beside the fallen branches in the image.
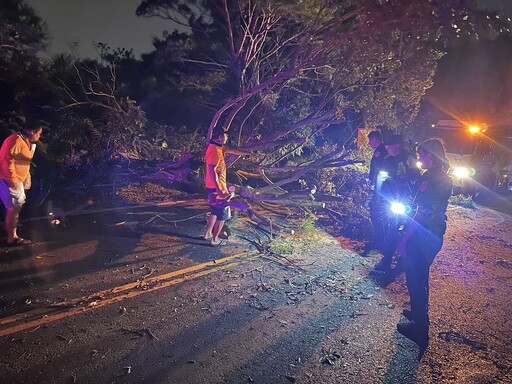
[203,127,258,245]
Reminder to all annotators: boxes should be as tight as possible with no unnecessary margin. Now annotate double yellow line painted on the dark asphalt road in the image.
[0,251,259,337]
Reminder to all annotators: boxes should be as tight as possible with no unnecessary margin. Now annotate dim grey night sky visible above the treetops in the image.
[27,0,512,58]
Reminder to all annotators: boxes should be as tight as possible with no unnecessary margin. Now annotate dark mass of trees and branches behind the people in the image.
[0,0,511,207]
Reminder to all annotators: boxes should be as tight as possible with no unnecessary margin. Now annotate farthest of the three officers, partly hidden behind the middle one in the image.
[368,131,388,252]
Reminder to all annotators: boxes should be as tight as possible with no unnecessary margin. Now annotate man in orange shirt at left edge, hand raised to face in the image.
[0,124,43,246]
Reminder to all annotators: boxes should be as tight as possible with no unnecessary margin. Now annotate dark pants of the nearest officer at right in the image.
[405,228,443,328]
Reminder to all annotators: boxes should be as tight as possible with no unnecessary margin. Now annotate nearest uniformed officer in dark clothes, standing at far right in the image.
[397,139,452,358]
